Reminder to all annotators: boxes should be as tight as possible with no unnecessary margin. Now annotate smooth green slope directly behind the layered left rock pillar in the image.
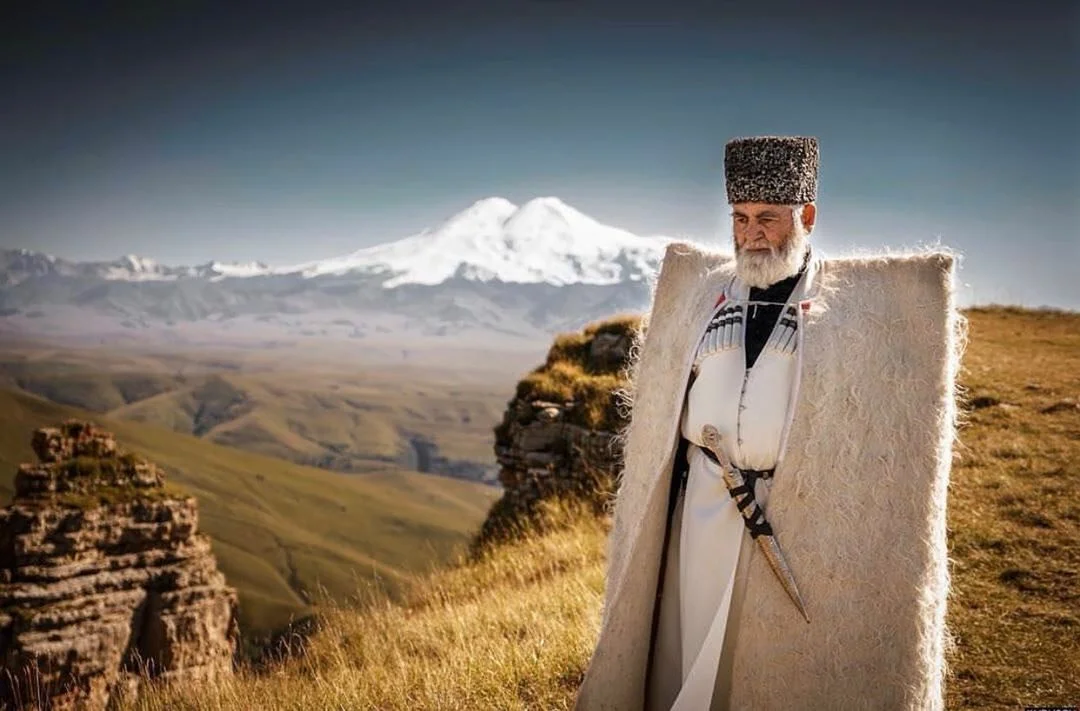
[0,390,497,634]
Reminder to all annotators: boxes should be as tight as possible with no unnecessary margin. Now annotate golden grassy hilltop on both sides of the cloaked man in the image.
[122,309,1080,711]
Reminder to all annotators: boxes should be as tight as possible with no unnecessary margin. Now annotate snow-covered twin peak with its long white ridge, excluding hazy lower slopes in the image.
[3,197,670,289]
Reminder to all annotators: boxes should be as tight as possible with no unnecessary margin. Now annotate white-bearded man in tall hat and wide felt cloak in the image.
[577,136,961,711]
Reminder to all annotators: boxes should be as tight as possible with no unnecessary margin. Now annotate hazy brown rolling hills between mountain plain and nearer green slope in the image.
[0,346,516,477]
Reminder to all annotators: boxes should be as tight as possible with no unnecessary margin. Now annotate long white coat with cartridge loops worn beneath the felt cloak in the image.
[657,255,819,711]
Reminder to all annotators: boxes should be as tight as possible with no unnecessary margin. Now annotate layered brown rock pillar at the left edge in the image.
[0,421,238,709]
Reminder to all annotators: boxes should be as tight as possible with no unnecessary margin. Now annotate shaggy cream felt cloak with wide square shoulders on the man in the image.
[576,242,963,711]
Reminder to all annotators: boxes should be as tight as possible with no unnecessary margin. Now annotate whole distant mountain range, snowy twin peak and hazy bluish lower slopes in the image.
[0,198,671,344]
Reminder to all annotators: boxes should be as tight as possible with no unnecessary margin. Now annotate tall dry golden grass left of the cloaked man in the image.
[127,499,607,711]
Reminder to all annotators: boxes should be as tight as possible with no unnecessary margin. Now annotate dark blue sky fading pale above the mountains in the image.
[0,0,1080,308]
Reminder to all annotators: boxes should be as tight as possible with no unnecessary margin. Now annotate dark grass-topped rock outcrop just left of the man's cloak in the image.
[473,316,640,550]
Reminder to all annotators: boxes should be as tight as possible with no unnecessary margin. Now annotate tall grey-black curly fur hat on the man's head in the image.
[724,136,820,205]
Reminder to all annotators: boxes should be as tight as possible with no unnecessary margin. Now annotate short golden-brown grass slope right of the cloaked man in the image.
[947,308,1080,709]
